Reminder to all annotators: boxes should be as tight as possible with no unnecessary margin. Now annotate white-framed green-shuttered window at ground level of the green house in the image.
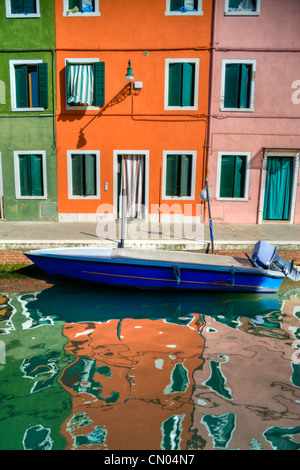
[14,151,47,199]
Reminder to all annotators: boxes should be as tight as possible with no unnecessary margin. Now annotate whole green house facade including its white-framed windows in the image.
[0,0,57,221]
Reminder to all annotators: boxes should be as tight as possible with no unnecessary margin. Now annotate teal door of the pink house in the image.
[263,157,294,220]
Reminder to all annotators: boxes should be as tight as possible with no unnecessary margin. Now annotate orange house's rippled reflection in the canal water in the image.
[60,315,204,450]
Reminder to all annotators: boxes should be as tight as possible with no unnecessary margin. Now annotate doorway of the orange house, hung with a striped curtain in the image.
[118,154,145,219]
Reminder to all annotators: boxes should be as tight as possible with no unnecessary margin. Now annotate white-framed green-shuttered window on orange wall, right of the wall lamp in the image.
[165,59,199,110]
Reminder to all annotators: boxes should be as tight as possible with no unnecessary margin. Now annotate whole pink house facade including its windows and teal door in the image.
[207,0,300,224]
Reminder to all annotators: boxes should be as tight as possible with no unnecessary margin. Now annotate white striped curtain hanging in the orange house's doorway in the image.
[121,155,144,218]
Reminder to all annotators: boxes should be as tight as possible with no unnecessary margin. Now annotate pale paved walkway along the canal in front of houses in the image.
[0,221,300,252]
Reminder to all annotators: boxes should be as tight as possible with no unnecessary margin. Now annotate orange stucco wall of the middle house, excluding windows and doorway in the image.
[55,0,211,217]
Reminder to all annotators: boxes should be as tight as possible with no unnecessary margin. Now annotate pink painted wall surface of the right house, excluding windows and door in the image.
[209,0,300,224]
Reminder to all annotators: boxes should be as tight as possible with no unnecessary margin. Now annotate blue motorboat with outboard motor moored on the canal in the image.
[25,241,300,293]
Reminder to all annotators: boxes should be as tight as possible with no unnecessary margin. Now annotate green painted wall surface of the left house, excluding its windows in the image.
[0,0,57,221]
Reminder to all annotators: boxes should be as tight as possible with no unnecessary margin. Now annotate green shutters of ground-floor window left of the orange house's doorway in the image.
[71,153,97,196]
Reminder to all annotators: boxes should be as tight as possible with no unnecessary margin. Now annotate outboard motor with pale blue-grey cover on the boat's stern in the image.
[251,241,300,281]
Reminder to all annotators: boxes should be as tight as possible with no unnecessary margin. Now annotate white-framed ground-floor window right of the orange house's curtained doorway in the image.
[163,151,196,199]
